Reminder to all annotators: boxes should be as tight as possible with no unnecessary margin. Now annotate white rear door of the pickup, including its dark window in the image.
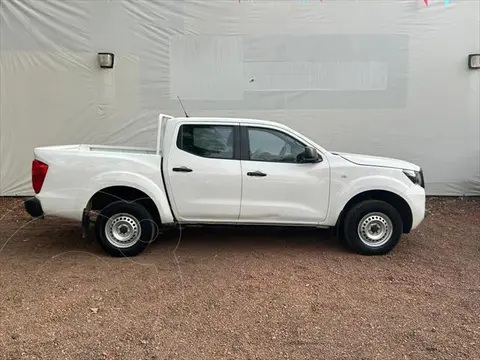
[167,121,242,223]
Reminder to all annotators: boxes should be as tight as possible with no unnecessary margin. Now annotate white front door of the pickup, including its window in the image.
[240,126,330,224]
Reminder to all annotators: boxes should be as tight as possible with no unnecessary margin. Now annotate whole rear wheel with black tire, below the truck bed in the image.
[95,200,156,257]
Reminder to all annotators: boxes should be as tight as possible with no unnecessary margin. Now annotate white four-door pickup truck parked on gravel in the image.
[25,114,425,256]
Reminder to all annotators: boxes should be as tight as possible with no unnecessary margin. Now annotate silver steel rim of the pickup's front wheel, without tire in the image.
[358,212,393,247]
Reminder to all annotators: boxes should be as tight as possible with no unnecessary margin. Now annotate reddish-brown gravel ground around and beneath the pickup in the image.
[0,198,480,360]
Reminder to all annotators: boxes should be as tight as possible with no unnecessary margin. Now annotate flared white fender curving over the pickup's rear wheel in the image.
[77,171,174,224]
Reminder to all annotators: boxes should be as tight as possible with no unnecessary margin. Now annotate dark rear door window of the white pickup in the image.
[177,124,234,159]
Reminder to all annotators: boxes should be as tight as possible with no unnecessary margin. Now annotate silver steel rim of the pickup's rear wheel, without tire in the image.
[105,213,142,249]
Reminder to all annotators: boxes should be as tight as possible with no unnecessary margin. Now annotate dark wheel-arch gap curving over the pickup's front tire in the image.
[335,190,413,235]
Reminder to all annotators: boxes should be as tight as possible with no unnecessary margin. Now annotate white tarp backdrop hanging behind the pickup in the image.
[0,0,480,195]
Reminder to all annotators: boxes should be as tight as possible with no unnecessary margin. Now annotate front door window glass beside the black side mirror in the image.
[248,128,305,163]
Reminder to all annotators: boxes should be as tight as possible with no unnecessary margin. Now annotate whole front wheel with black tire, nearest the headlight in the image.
[344,200,403,255]
